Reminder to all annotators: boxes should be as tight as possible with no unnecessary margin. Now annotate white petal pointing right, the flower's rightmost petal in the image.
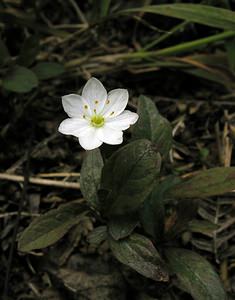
[106,110,139,130]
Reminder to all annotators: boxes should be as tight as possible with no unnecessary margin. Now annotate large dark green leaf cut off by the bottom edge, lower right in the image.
[166,248,227,300]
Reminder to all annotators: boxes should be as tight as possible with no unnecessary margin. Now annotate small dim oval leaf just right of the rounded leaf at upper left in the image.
[32,62,65,80]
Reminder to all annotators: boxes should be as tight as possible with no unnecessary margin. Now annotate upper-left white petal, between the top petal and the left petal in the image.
[62,94,84,117]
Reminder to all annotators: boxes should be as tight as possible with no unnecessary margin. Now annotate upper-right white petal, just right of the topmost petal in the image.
[102,89,129,118]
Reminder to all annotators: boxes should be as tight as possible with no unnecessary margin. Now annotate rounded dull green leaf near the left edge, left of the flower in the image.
[2,66,38,93]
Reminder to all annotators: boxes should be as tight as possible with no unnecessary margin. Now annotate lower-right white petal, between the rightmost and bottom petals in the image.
[97,126,123,145]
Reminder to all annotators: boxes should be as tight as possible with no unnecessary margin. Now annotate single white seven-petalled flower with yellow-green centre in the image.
[58,77,138,150]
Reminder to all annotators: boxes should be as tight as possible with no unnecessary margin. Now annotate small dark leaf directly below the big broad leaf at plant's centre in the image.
[108,215,138,240]
